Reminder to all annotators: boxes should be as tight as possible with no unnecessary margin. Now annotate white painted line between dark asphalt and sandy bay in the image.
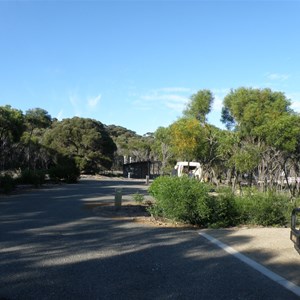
[199,232,300,296]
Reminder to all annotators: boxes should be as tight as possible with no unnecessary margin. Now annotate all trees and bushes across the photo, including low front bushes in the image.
[0,87,300,226]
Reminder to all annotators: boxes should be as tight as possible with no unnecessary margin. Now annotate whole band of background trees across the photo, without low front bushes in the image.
[0,88,300,196]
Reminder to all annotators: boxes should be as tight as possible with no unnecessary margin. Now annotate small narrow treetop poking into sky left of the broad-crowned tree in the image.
[183,90,214,123]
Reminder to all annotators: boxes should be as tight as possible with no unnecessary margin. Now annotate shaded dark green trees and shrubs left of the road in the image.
[0,105,116,193]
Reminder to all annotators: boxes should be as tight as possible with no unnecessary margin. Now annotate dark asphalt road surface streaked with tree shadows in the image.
[0,180,299,300]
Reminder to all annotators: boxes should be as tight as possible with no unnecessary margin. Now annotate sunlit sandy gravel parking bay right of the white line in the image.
[205,227,300,286]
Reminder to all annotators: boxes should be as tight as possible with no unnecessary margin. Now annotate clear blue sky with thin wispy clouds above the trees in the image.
[0,0,300,135]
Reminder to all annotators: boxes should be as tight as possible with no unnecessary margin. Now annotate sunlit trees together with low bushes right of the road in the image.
[145,88,300,227]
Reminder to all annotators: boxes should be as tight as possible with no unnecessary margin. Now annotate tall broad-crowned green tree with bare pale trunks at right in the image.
[222,88,300,193]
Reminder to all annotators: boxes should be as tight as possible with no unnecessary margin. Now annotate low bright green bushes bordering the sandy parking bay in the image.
[149,177,295,228]
